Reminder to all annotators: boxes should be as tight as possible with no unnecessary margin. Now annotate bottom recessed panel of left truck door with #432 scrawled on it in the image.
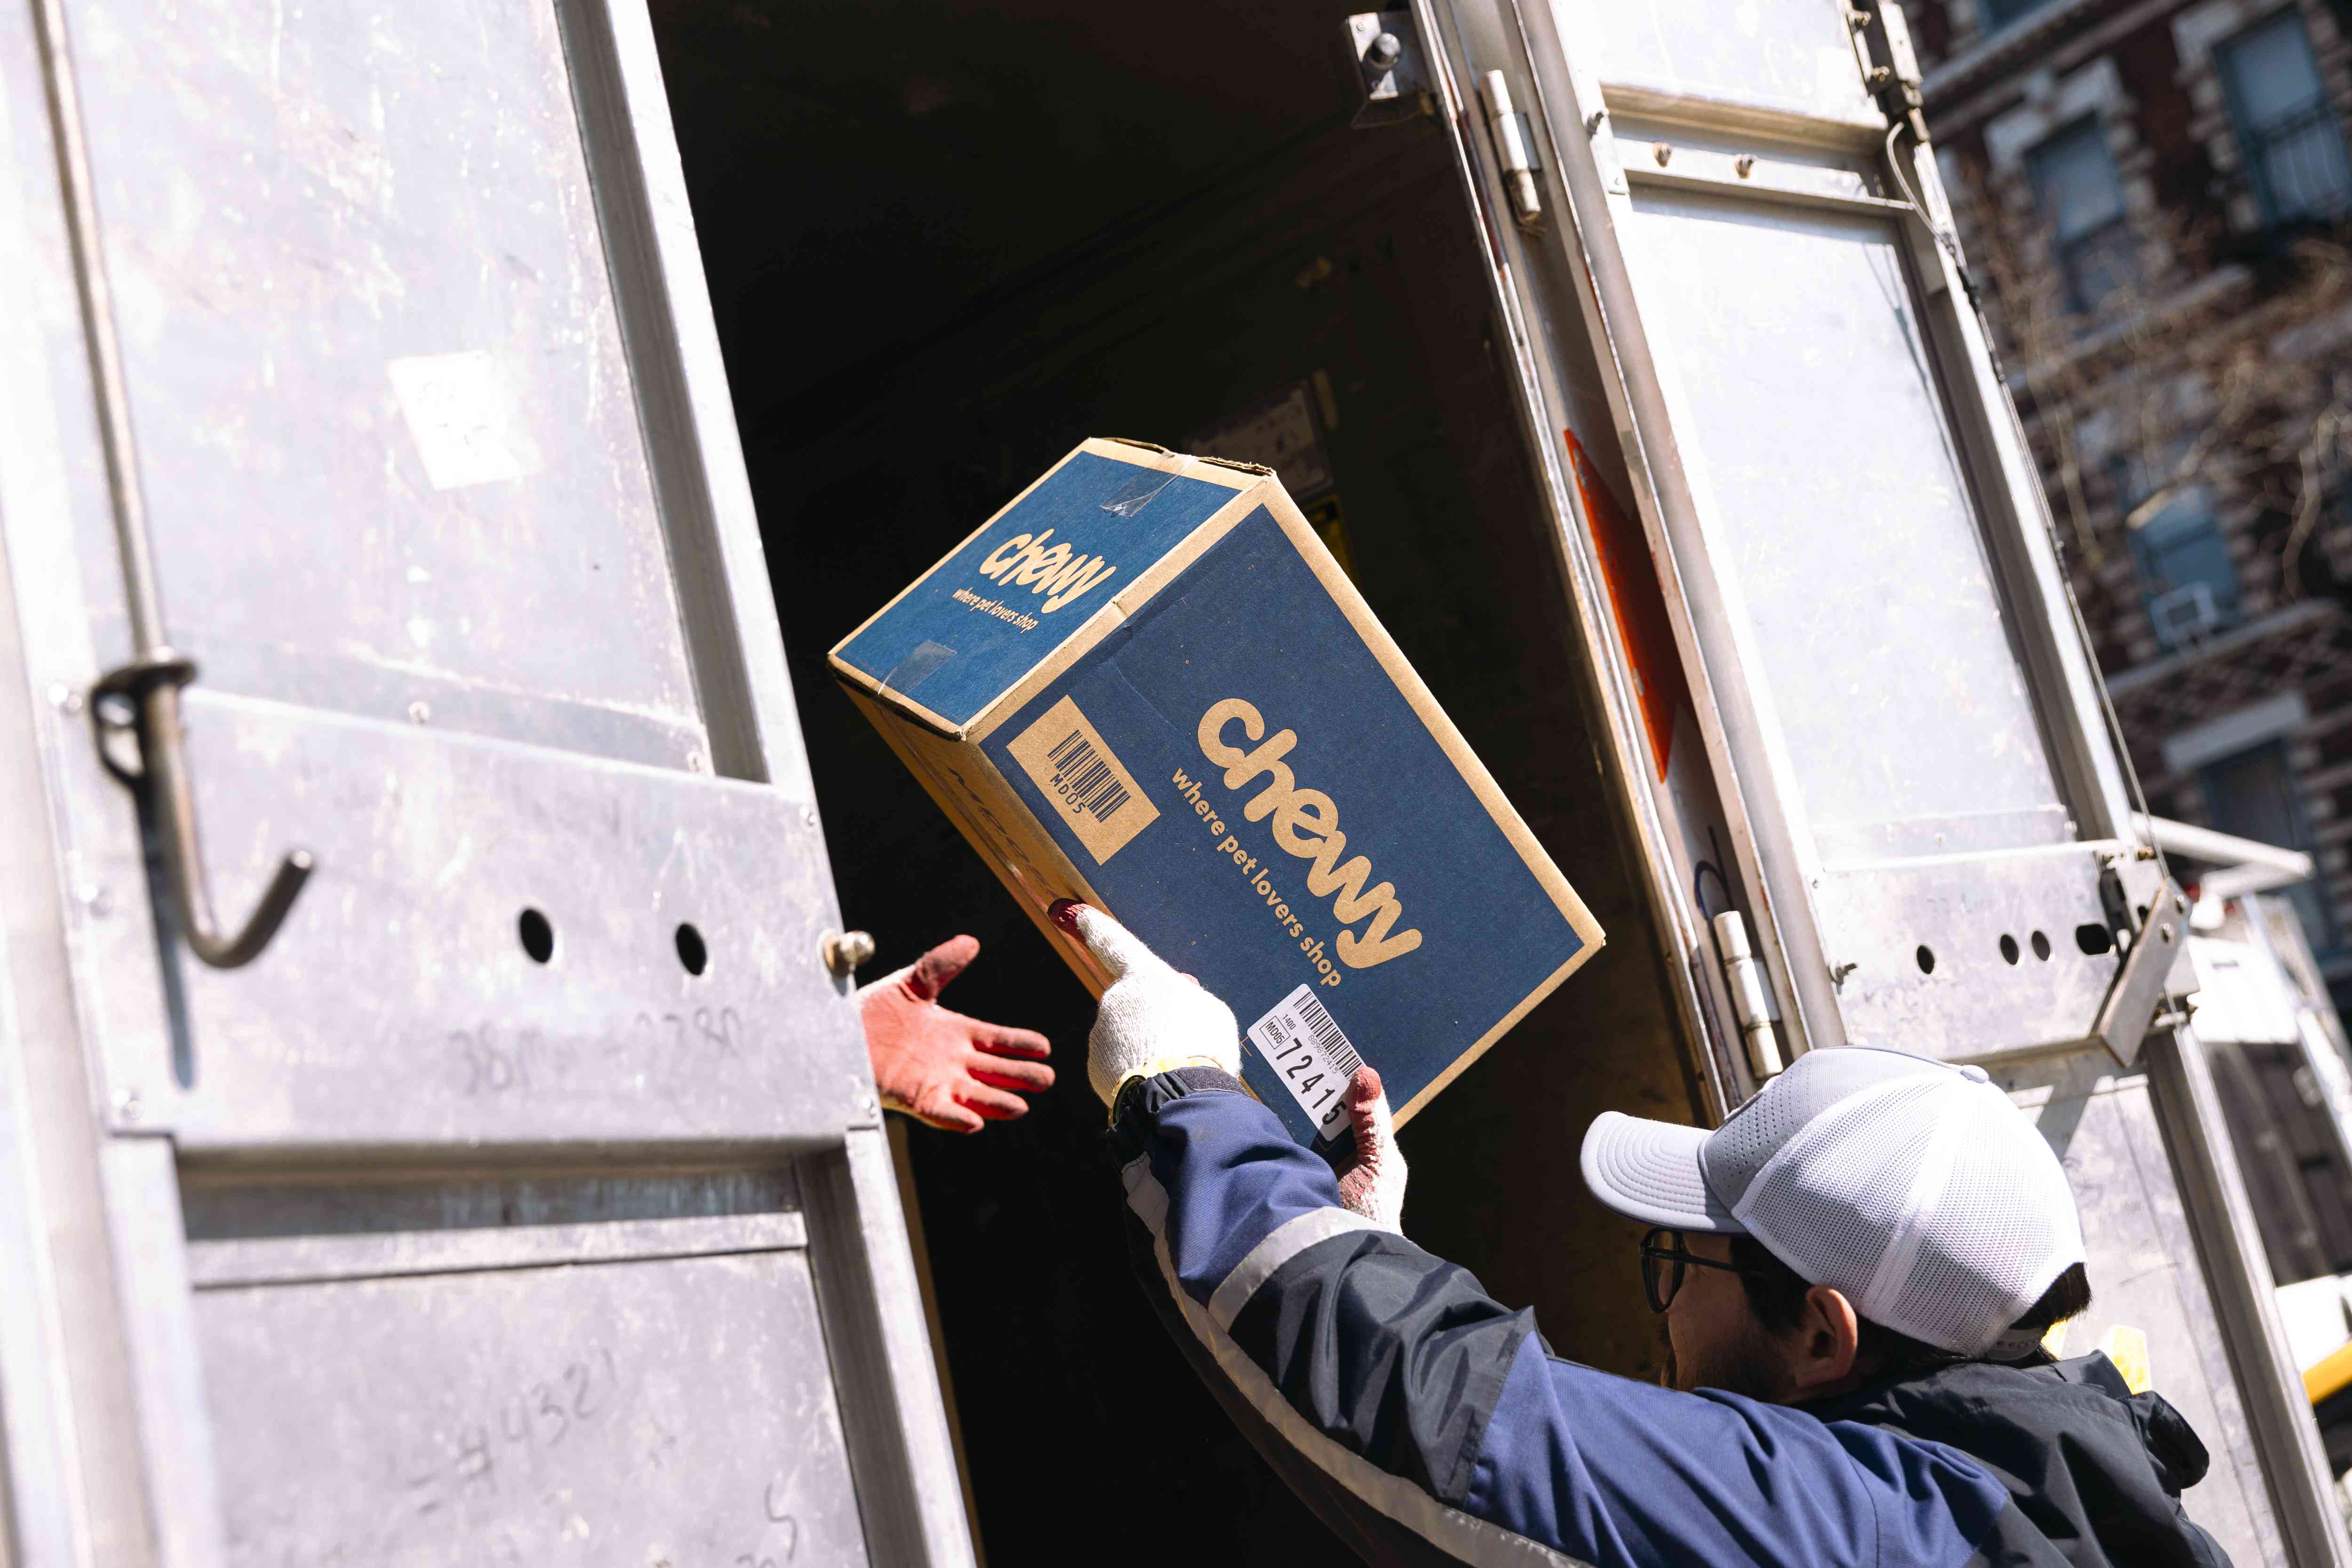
[195,1248,868,1568]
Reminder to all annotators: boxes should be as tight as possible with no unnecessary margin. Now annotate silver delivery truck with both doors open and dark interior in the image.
[0,0,2352,1568]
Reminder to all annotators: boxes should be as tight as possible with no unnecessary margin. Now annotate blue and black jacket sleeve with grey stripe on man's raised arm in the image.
[1112,1067,2009,1568]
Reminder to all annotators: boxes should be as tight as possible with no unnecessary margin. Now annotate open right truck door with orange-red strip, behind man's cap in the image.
[1350,0,2345,1563]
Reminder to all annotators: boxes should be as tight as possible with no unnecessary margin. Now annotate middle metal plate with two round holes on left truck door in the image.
[87,686,877,1154]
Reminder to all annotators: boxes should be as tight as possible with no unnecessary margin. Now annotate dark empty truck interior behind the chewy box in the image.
[654,0,1700,1566]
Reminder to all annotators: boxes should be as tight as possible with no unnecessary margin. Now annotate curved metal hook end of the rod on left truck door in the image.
[89,649,315,969]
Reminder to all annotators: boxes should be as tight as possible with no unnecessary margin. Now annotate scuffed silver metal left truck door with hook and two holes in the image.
[0,0,971,1568]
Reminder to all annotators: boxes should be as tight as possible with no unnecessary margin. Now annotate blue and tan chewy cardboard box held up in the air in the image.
[833,439,1602,1143]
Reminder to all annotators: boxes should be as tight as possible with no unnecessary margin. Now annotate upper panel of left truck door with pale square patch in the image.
[66,0,706,769]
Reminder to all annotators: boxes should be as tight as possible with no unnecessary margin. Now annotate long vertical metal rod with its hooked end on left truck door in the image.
[33,0,310,969]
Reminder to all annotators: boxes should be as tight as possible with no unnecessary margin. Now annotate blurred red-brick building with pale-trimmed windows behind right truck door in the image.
[1903,0,2352,1006]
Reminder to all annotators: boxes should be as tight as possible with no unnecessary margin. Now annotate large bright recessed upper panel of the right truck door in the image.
[1625,193,2072,865]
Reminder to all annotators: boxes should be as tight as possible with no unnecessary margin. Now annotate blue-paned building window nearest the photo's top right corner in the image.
[2213,7,2352,223]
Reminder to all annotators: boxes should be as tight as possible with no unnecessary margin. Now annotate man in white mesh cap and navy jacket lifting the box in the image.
[1054,905,2227,1568]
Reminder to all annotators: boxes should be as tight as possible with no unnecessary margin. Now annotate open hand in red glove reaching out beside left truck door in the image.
[858,936,1054,1133]
